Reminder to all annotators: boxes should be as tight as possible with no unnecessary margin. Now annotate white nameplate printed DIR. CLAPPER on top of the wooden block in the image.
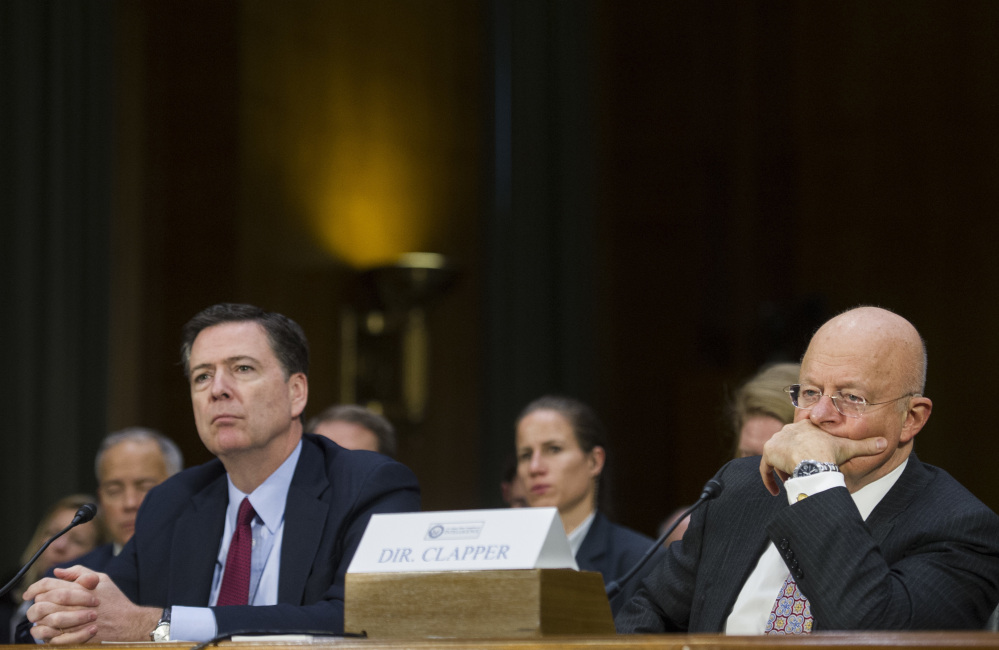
[347,508,579,573]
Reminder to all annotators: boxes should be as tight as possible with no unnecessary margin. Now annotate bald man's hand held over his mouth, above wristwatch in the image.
[760,419,888,496]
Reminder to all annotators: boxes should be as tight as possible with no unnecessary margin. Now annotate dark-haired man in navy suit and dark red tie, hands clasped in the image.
[26,304,419,644]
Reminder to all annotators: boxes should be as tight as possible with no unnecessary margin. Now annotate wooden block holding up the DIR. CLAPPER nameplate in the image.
[344,569,615,639]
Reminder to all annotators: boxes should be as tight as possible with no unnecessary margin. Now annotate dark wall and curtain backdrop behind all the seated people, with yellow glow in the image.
[0,0,999,566]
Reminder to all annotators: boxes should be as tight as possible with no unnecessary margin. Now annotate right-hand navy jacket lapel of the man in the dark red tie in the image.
[278,439,330,605]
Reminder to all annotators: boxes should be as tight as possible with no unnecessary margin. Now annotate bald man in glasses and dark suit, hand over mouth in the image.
[615,307,999,634]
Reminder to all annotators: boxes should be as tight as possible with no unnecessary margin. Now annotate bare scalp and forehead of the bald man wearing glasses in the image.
[803,307,926,399]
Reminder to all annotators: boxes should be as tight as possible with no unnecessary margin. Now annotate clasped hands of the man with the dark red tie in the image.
[24,566,162,645]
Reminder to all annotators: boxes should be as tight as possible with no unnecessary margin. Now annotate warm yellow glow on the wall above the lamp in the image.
[241,0,467,269]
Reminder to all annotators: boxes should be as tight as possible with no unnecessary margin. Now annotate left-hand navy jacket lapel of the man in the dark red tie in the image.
[169,473,229,607]
